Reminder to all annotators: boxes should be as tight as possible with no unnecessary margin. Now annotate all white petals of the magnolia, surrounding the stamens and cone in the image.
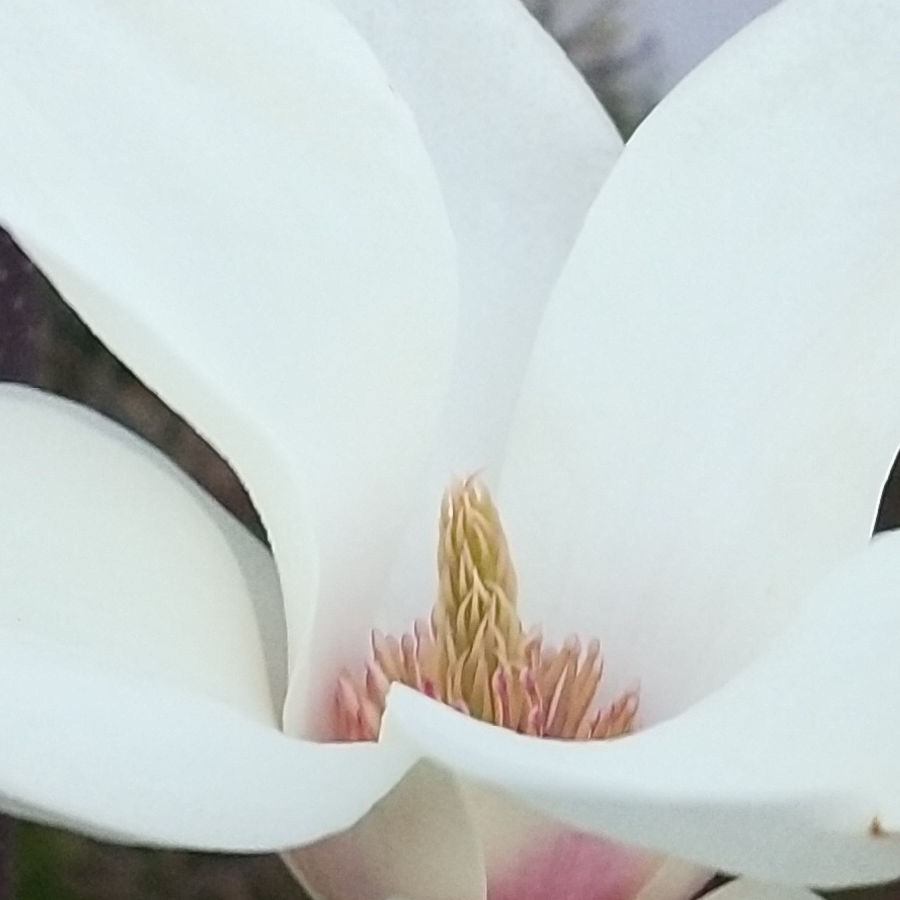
[0,0,900,900]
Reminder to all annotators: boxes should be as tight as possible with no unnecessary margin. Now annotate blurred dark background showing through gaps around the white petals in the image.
[0,0,900,900]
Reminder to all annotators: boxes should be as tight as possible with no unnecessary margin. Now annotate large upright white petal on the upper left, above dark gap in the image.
[0,0,457,732]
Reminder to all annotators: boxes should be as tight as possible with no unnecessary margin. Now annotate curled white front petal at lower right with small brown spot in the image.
[385,532,900,887]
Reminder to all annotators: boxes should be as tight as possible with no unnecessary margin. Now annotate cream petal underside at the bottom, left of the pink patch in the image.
[285,764,485,900]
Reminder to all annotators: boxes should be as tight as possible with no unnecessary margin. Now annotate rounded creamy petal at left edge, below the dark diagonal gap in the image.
[0,385,283,733]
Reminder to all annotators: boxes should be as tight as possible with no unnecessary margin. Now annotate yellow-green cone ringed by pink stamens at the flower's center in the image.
[335,477,638,741]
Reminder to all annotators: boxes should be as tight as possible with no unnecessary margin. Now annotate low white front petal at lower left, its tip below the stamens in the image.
[0,627,409,852]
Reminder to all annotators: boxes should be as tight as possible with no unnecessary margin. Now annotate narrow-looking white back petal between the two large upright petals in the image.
[338,0,622,629]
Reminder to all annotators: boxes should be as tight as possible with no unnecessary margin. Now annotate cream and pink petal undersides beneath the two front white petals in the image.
[285,764,711,900]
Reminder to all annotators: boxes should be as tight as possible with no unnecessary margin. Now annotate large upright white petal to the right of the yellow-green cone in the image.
[499,0,900,721]
